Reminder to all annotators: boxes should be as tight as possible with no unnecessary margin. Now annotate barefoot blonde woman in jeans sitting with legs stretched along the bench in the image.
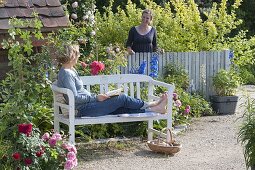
[57,45,167,117]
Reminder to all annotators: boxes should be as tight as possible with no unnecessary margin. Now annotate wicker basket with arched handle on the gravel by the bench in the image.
[147,129,182,155]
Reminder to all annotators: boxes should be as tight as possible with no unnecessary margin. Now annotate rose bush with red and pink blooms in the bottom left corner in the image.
[7,123,78,170]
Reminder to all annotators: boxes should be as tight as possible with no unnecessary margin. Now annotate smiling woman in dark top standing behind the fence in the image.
[126,9,157,54]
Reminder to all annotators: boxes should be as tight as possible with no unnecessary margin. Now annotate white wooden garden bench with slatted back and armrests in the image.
[51,74,174,144]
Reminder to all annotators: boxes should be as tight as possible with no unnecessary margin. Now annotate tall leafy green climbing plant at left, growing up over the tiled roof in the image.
[0,14,52,140]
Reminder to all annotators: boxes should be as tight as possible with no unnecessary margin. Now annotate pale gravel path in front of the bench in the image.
[76,86,255,170]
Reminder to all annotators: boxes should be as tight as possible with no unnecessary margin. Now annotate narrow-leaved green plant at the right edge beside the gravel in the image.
[238,96,255,168]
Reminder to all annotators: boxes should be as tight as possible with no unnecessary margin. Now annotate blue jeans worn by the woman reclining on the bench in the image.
[78,94,145,117]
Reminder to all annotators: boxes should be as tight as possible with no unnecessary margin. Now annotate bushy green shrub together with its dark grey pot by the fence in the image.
[210,69,240,114]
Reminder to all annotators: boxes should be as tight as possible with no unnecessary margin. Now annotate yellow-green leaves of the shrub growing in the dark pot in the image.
[213,69,240,96]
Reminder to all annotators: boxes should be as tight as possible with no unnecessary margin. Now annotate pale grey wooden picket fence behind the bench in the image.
[121,50,231,100]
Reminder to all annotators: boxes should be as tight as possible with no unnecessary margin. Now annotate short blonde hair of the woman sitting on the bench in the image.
[53,44,79,64]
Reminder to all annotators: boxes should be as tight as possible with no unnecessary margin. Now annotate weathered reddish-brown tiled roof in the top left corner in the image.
[0,0,69,32]
